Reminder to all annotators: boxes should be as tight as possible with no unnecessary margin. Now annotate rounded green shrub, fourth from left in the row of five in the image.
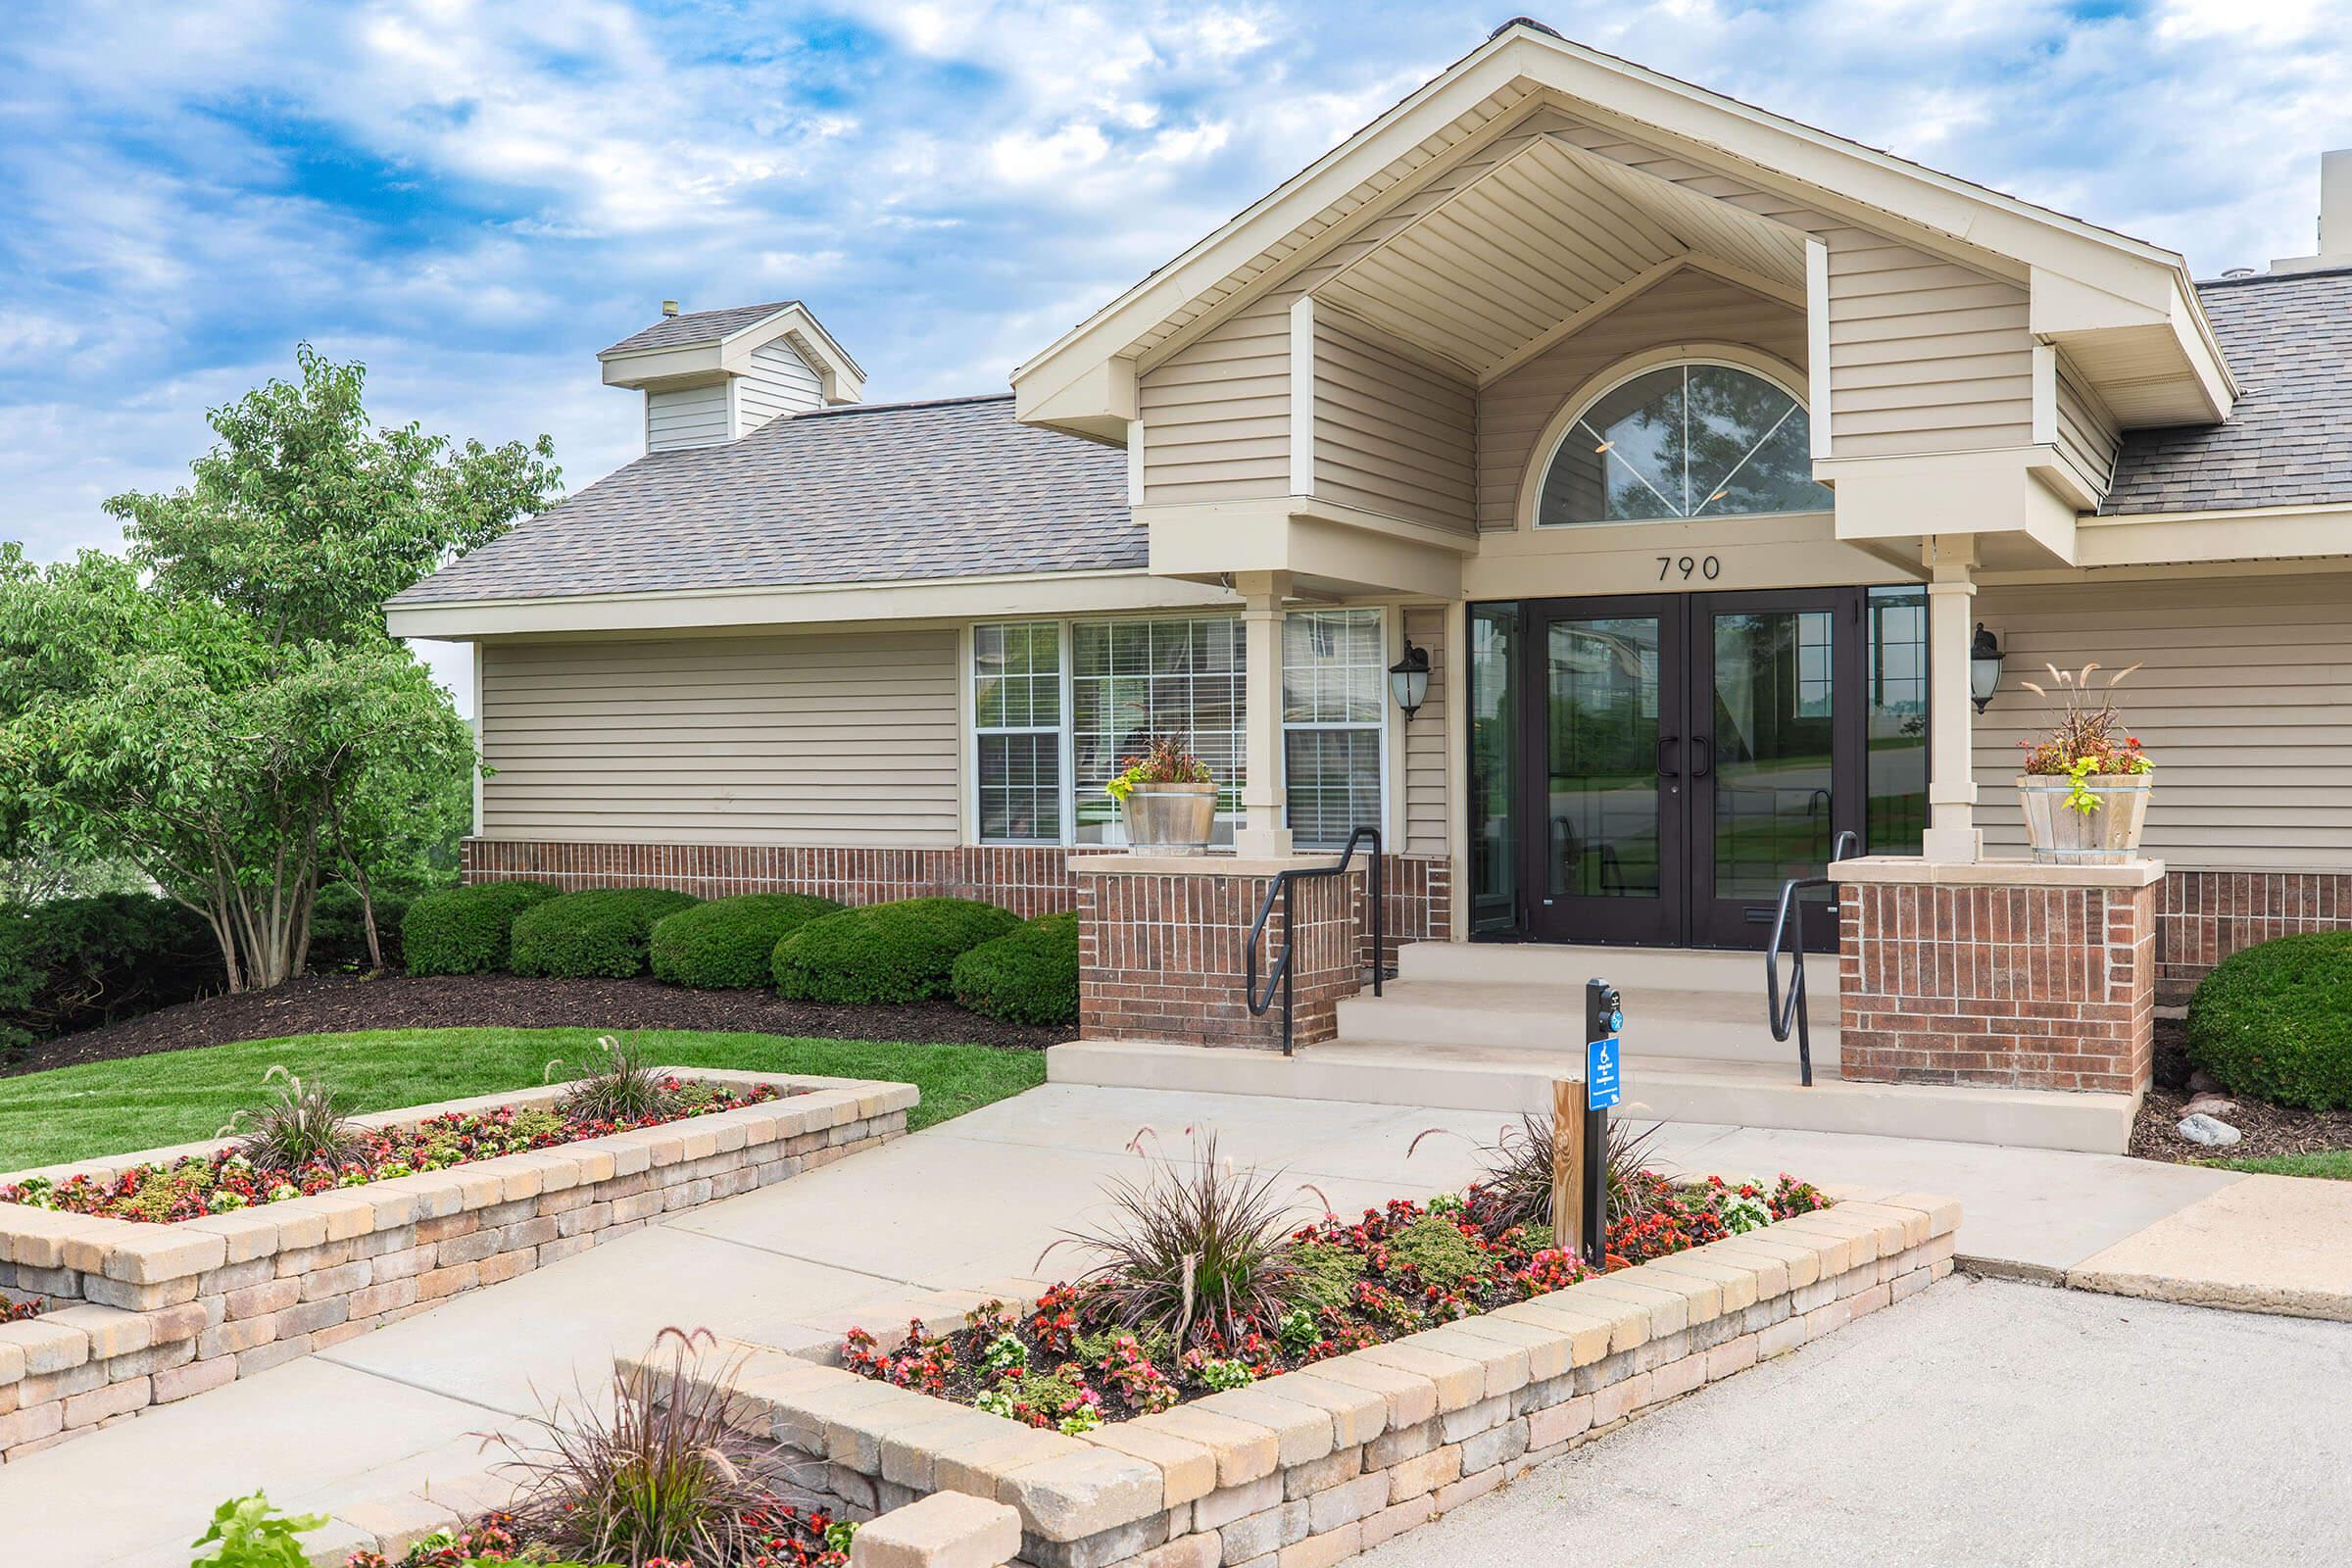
[776,898,1021,1002]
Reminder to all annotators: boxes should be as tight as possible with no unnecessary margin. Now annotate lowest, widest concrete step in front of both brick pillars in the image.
[1047,1039,2135,1154]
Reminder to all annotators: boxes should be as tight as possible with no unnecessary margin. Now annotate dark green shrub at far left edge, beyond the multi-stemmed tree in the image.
[0,894,228,1049]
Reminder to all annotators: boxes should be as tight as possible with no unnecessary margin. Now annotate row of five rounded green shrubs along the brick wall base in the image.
[400,882,1077,1025]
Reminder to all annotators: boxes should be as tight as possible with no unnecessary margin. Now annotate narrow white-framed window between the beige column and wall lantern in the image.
[1282,609,1388,849]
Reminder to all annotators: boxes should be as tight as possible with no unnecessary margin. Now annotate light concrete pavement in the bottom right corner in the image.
[1354,1278,2352,1568]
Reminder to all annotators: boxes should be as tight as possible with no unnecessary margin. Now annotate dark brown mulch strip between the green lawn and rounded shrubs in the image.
[0,976,1075,1077]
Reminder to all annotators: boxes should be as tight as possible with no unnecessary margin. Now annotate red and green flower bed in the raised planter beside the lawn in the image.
[0,1074,805,1225]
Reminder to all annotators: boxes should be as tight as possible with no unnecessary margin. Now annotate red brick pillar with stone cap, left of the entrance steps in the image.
[1070,856,1364,1049]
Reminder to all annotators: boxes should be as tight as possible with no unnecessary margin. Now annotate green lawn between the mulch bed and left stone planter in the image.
[0,1030,1045,1171]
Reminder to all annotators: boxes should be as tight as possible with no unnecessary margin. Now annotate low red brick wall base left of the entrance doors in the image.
[461,839,1453,945]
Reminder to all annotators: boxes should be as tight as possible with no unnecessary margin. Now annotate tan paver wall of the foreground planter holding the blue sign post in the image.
[649,1195,1959,1568]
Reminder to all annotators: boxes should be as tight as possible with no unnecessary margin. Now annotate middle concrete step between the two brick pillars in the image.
[1339,973,1837,1074]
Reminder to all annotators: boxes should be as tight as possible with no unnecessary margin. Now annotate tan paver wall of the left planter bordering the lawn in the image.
[0,1067,917,1460]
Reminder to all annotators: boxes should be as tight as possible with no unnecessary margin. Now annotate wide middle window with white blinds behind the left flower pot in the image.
[1070,615,1247,844]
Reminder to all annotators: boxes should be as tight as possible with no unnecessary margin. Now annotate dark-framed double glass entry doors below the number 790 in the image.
[1498,588,1872,953]
